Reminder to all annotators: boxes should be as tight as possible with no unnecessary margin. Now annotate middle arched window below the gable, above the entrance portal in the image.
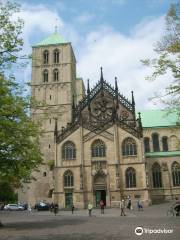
[91,139,106,157]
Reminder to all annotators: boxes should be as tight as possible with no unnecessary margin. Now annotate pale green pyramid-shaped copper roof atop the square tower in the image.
[34,33,66,47]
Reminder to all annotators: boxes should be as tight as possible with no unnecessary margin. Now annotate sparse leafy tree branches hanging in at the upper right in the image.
[142,4,180,114]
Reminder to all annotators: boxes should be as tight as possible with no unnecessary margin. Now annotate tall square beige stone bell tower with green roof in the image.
[19,31,84,204]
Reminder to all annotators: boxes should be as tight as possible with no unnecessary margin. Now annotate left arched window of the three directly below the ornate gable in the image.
[62,141,76,160]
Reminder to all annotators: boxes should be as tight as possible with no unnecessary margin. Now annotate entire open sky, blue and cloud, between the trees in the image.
[15,0,176,109]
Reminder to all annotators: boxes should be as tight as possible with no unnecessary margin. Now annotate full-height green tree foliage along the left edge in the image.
[0,2,42,205]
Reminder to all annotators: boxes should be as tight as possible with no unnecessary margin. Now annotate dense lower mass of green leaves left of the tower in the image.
[0,77,42,187]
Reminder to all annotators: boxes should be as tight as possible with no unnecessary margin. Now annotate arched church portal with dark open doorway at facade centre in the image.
[93,170,107,207]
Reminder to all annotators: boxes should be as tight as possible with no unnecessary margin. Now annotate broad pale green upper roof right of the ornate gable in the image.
[141,110,178,128]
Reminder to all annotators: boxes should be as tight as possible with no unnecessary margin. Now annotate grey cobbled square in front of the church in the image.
[0,204,180,240]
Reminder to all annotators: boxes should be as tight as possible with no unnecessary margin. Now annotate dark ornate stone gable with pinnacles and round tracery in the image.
[56,68,142,142]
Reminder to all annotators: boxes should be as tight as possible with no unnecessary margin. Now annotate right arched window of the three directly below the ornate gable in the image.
[122,138,137,156]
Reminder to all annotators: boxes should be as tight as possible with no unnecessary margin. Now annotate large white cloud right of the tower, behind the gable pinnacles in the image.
[78,17,171,109]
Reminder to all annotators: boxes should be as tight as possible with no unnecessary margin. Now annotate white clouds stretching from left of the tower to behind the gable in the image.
[14,5,171,109]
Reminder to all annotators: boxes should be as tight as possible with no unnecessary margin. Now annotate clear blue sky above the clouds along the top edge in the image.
[19,0,175,39]
